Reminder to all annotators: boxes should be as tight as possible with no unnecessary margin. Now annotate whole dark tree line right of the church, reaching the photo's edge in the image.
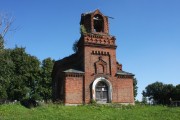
[142,82,180,105]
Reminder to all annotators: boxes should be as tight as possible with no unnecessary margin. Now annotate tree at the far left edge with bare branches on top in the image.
[0,12,14,99]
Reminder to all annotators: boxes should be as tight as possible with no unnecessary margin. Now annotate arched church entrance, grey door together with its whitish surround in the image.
[92,77,112,103]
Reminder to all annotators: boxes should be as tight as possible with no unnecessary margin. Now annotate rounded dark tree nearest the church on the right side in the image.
[142,82,174,104]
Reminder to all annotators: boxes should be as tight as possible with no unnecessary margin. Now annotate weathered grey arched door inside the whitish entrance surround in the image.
[95,81,109,103]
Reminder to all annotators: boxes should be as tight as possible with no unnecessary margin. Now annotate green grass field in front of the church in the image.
[0,104,180,120]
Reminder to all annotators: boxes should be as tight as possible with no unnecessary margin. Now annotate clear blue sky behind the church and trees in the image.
[0,0,180,100]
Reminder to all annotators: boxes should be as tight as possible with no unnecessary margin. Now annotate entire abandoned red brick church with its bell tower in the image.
[52,10,134,104]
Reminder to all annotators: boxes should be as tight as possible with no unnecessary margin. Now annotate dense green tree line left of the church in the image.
[0,46,54,101]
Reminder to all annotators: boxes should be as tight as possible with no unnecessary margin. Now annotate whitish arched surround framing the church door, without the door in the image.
[92,77,112,103]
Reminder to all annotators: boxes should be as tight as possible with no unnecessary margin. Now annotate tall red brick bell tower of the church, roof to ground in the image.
[78,9,117,102]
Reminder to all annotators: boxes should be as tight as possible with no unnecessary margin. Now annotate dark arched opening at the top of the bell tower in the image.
[93,14,104,32]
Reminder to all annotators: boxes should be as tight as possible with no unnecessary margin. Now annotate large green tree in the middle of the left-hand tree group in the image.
[8,47,40,100]
